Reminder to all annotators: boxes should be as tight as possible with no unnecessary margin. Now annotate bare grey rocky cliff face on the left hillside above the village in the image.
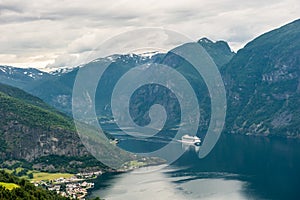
[1,123,89,161]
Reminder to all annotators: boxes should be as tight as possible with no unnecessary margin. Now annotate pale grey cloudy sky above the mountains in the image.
[0,0,300,70]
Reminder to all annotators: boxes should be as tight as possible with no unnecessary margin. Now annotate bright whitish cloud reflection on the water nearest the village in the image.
[93,169,185,200]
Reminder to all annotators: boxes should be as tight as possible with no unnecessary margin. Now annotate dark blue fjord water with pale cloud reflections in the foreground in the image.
[91,134,300,200]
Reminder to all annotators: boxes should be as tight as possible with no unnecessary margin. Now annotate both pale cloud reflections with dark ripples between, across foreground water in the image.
[93,168,249,200]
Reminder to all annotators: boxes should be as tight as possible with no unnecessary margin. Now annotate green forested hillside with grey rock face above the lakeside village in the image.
[0,84,142,172]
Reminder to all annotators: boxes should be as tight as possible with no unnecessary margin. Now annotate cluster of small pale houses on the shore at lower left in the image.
[34,171,102,200]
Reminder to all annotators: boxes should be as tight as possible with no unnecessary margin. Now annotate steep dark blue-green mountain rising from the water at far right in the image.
[222,20,300,137]
